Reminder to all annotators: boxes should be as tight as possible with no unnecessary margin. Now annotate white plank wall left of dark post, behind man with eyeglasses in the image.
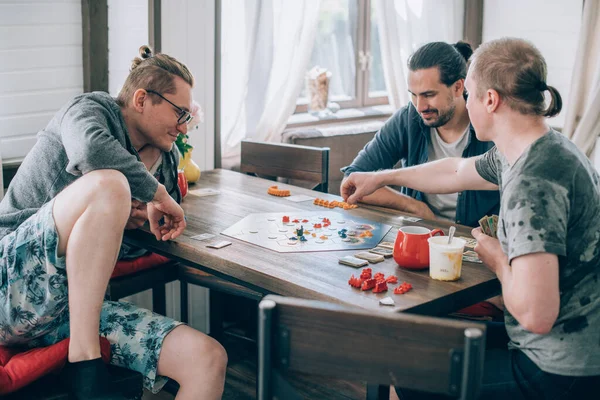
[0,0,83,162]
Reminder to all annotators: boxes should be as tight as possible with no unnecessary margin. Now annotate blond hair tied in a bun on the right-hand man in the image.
[471,38,562,117]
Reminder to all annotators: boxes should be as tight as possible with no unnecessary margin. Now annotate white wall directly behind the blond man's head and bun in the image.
[483,0,583,127]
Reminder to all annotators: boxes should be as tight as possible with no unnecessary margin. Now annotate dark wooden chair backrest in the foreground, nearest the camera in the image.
[259,295,485,400]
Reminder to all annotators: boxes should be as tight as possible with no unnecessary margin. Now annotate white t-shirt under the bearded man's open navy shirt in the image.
[424,126,469,221]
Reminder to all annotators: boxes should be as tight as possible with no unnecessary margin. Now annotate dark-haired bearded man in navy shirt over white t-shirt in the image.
[342,42,500,226]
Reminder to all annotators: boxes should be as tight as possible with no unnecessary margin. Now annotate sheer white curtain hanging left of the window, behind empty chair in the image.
[221,0,320,168]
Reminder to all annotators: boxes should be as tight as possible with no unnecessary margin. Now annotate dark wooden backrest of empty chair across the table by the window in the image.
[240,140,329,193]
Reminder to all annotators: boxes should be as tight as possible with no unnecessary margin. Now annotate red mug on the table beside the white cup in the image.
[393,226,444,269]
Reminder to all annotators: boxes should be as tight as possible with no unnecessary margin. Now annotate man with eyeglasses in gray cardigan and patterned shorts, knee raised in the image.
[0,46,227,400]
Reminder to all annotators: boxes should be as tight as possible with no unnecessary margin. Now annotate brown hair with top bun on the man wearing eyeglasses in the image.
[117,45,194,107]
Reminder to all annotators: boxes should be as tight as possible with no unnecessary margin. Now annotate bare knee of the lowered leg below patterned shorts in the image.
[157,325,227,400]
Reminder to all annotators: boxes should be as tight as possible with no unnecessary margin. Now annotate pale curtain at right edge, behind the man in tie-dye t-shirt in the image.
[563,1,600,156]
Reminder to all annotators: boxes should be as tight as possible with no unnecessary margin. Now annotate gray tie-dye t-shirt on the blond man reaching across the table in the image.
[475,131,600,376]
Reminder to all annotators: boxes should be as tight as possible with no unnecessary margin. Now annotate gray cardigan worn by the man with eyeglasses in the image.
[0,92,181,239]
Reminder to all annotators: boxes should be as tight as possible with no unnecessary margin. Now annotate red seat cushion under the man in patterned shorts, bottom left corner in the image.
[0,337,110,396]
